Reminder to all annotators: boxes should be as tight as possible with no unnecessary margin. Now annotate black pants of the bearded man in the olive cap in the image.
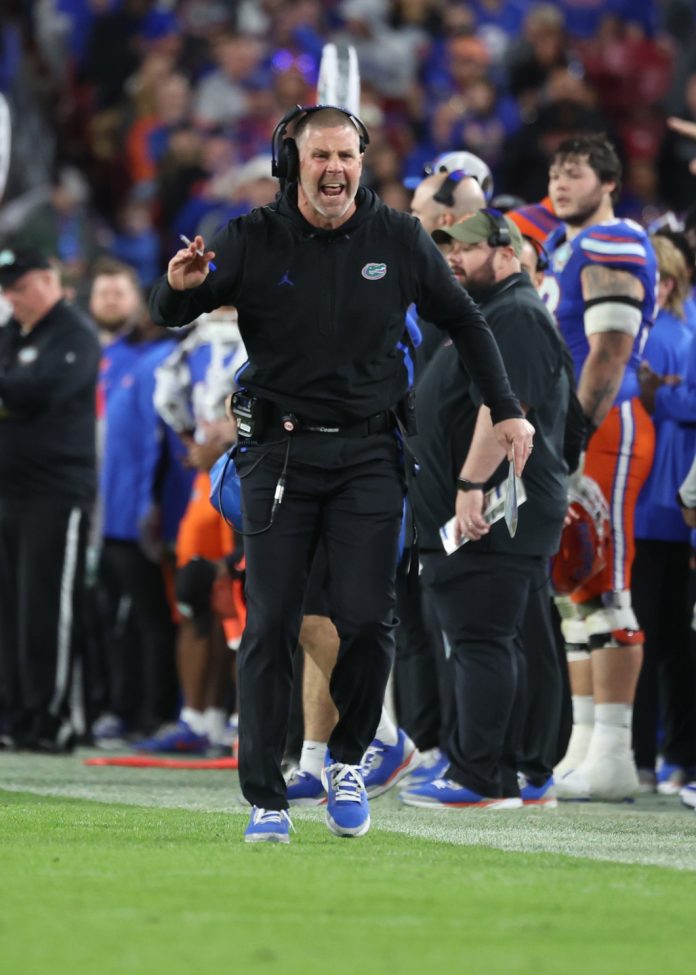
[424,545,557,797]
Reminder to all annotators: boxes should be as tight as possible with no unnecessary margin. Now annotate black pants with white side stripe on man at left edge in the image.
[0,499,89,745]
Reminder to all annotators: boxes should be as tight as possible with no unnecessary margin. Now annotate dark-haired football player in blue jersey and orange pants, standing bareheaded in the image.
[545,135,657,800]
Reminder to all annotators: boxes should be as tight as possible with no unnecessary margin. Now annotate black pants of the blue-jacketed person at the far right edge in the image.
[631,539,696,769]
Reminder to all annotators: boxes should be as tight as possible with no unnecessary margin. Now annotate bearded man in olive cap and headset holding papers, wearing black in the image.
[401,210,570,808]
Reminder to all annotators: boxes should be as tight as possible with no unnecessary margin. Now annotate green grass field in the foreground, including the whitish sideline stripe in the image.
[0,755,696,975]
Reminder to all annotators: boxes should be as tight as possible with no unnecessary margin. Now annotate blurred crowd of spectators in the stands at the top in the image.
[0,0,696,291]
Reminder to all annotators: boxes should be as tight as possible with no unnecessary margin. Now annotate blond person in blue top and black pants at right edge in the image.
[632,236,696,794]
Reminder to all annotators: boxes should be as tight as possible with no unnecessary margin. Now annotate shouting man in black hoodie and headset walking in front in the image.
[150,106,533,841]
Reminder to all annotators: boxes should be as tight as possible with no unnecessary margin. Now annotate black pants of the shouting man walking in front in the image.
[236,433,404,809]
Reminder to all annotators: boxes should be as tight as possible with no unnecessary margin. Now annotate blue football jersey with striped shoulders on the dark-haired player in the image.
[541,220,658,403]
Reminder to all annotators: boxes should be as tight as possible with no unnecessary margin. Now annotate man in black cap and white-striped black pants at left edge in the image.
[0,247,100,752]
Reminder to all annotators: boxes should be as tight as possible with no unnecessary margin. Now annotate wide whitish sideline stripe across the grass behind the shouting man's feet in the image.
[0,776,696,872]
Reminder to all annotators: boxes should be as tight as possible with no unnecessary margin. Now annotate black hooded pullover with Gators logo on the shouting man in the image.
[150,185,522,423]
